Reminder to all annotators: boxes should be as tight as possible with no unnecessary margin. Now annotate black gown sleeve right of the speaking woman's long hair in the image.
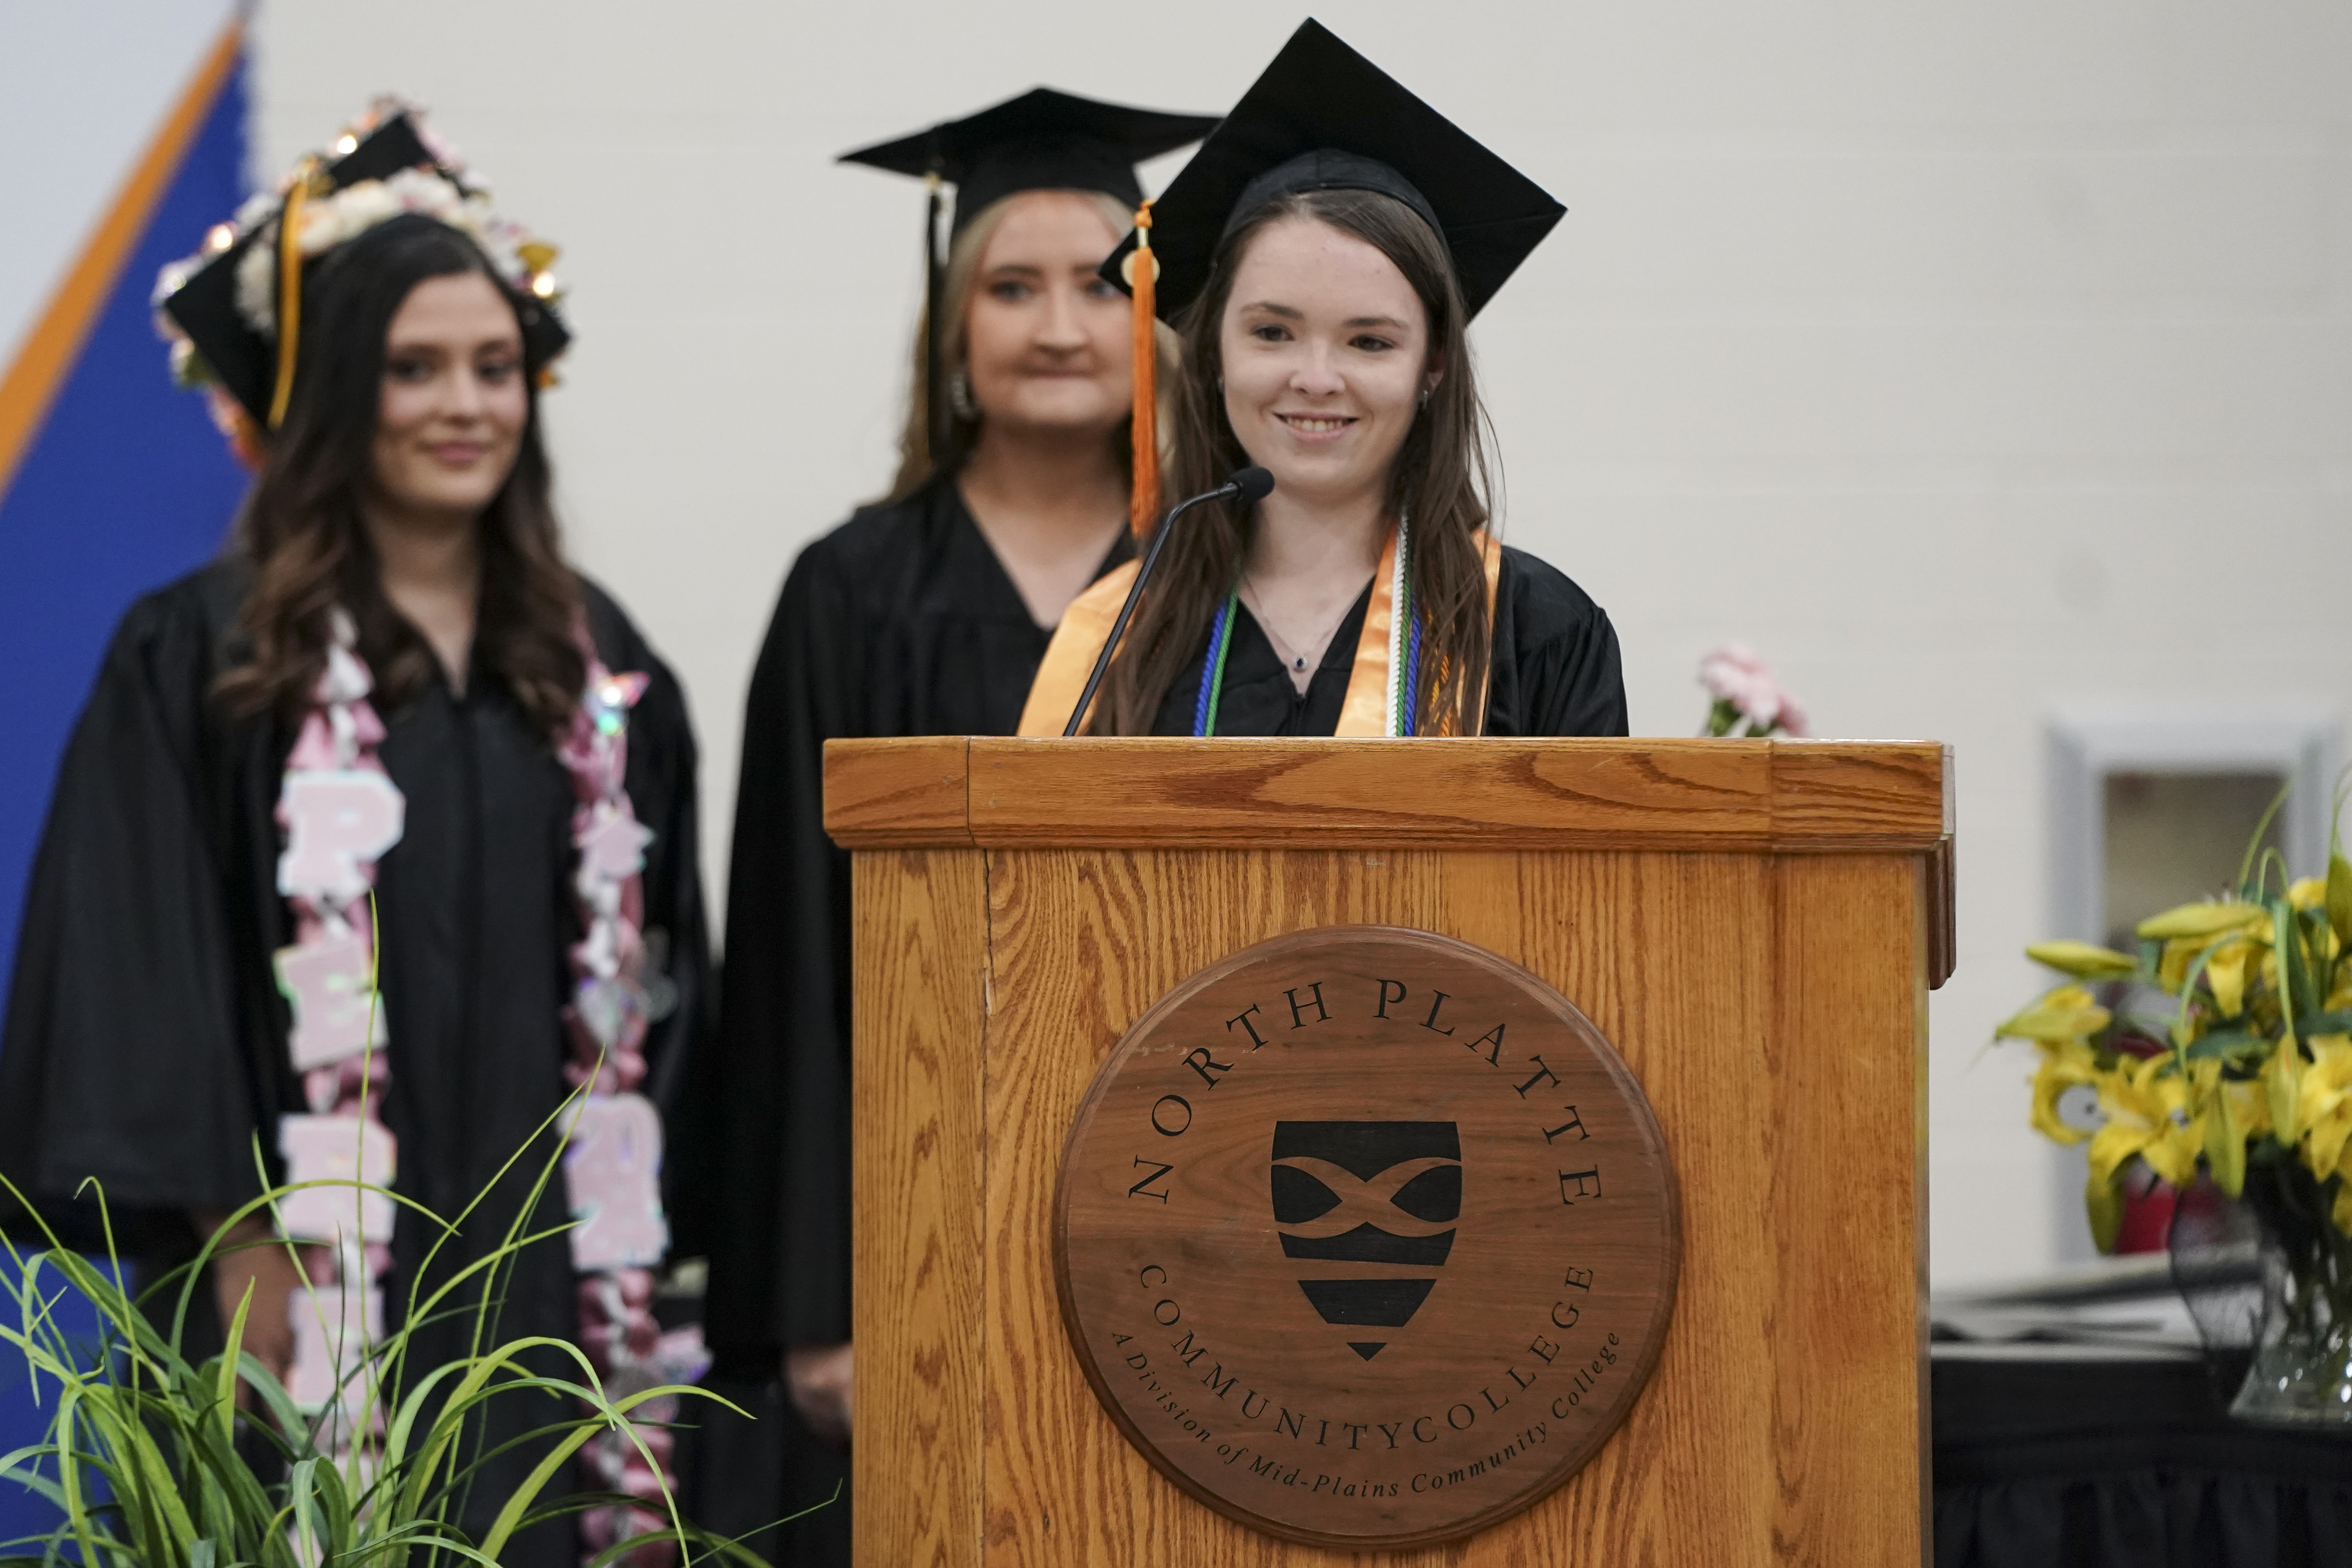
[1486,550,1628,736]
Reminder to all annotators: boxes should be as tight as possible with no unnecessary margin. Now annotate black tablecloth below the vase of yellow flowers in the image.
[1933,1347,2352,1568]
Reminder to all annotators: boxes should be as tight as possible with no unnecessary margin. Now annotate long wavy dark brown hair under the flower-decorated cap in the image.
[216,214,588,740]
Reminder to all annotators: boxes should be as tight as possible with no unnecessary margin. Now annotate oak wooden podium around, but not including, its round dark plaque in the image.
[826,738,1952,1568]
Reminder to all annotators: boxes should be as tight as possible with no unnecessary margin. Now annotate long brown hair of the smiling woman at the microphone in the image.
[1089,191,1491,736]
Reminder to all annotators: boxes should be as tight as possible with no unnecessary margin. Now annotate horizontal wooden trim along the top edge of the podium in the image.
[826,738,1952,853]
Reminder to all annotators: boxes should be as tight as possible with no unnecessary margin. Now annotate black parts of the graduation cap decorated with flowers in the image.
[162,111,572,428]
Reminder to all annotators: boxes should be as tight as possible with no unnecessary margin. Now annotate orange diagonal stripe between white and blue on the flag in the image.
[0,14,245,496]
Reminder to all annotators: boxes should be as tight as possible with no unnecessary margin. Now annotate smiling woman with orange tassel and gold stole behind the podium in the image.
[1021,21,1625,736]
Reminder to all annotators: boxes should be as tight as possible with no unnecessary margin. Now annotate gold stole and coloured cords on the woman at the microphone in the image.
[1014,524,1503,736]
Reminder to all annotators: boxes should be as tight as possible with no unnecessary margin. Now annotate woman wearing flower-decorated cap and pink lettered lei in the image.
[0,103,708,1563]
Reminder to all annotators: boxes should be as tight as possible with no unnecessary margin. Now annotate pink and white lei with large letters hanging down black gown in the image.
[275,609,703,1552]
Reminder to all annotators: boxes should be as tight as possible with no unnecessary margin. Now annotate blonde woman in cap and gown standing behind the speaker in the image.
[706,87,1216,1561]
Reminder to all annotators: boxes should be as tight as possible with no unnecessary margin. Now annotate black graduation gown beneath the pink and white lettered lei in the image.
[0,562,710,1566]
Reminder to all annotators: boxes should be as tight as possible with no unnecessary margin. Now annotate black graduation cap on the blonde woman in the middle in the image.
[840,87,1216,233]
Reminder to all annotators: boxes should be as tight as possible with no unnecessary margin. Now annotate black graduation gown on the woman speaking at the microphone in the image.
[1152,545,1625,736]
